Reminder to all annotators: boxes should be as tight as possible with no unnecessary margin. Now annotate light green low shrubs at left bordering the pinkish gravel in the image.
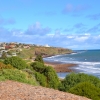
[0,69,36,85]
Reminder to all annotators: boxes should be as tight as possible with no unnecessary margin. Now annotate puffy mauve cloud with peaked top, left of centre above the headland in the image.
[25,22,51,35]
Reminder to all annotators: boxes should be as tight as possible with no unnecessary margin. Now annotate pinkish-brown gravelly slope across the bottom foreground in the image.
[0,81,90,100]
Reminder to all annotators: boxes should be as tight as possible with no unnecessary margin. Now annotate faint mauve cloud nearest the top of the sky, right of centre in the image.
[62,4,89,14]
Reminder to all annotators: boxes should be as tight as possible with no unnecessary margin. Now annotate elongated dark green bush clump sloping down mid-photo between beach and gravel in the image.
[31,58,60,89]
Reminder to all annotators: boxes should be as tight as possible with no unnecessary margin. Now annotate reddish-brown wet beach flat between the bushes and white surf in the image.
[45,62,77,72]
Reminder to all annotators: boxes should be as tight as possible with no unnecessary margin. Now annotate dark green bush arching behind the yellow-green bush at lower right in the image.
[59,73,100,91]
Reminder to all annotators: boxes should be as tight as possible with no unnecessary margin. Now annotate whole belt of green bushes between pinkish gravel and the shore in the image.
[0,49,100,100]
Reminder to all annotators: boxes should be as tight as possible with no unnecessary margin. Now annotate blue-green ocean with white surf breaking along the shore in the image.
[44,50,100,78]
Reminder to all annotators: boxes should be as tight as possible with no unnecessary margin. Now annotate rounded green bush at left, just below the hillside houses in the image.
[4,57,27,69]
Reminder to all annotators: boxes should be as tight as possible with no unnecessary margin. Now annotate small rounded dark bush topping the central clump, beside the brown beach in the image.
[31,62,45,73]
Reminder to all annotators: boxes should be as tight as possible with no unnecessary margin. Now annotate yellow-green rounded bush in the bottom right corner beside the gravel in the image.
[69,82,100,100]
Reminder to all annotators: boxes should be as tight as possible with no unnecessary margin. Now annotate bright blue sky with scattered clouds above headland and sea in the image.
[0,0,100,50]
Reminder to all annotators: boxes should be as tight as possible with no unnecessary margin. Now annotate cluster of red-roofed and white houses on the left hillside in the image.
[0,42,50,57]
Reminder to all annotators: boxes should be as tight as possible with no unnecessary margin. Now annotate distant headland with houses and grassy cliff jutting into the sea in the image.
[0,42,73,59]
